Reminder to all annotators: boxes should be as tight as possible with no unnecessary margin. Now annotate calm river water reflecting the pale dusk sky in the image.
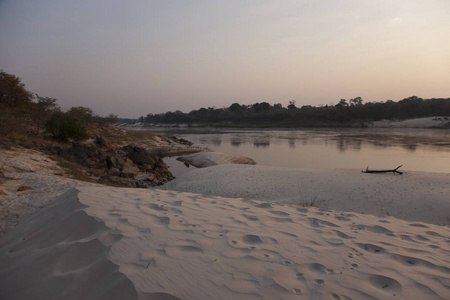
[144,128,450,176]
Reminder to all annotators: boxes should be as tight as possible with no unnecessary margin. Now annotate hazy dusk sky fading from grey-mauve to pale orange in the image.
[0,0,450,118]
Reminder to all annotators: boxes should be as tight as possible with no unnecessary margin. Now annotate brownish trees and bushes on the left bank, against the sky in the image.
[0,70,118,141]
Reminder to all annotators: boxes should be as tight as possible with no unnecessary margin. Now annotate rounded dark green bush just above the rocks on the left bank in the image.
[45,112,89,141]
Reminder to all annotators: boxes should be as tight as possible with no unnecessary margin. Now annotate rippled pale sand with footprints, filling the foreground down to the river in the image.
[0,149,450,300]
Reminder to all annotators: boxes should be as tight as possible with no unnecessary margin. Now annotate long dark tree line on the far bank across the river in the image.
[139,96,450,127]
